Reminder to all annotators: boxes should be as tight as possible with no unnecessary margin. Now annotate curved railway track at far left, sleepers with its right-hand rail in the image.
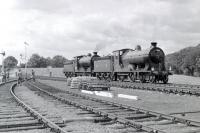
[0,81,65,133]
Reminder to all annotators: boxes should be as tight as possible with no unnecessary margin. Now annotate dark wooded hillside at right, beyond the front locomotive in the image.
[166,44,200,76]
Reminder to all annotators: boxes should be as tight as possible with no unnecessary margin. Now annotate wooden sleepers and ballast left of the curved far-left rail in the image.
[0,80,42,132]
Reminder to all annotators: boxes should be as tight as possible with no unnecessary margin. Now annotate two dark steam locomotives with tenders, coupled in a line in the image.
[63,42,171,83]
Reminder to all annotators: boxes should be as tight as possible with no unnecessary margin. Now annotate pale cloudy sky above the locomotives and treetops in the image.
[0,0,200,64]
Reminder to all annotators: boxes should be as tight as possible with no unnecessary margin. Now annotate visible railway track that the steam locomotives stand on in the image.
[38,76,200,96]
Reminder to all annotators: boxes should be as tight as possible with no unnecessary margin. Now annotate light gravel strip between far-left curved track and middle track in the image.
[16,86,139,133]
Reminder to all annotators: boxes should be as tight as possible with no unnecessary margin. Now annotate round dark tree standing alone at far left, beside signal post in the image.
[4,56,18,70]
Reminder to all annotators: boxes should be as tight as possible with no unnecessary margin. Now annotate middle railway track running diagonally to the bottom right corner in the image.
[28,82,200,133]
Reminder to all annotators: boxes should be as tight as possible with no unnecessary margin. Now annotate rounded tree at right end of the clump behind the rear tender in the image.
[52,55,67,67]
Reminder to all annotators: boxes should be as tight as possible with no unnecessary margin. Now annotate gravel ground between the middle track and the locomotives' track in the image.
[40,80,200,121]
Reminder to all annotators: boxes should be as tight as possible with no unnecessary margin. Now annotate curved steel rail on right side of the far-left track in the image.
[10,83,67,133]
